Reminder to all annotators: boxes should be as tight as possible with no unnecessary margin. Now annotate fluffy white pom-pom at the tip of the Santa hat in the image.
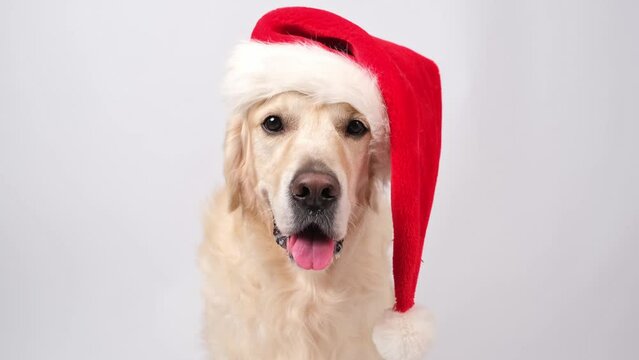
[373,305,433,360]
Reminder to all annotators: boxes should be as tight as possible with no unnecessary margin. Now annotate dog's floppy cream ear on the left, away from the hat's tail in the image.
[224,114,254,211]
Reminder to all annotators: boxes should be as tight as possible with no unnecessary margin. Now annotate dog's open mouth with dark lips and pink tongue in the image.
[273,224,343,270]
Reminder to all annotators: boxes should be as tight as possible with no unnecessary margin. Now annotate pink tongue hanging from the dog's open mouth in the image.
[287,235,335,270]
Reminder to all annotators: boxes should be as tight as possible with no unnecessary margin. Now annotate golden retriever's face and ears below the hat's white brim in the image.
[226,92,384,270]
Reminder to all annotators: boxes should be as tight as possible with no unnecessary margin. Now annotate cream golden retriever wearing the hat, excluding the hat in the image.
[200,92,393,359]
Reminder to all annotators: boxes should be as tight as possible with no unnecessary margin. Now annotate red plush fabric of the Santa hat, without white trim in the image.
[252,7,441,312]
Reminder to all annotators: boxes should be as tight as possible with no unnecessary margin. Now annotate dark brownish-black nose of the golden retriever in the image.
[291,171,340,210]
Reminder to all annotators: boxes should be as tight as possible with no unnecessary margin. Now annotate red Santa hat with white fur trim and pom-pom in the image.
[225,7,441,359]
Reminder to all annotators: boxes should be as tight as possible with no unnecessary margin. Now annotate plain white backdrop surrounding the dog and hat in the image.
[0,0,639,360]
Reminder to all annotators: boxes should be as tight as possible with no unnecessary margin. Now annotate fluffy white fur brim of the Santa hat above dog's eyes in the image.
[223,41,388,139]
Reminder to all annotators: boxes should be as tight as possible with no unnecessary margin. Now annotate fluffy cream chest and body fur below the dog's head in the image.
[200,192,392,359]
